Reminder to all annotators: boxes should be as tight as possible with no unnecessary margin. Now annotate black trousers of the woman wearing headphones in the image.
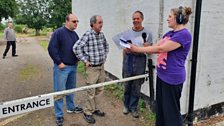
[156,76,183,126]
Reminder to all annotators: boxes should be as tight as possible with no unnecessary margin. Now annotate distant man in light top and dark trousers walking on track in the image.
[2,21,18,59]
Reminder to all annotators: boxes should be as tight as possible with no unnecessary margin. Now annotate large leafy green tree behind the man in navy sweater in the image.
[16,0,72,32]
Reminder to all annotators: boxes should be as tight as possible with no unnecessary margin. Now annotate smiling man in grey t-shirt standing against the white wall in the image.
[113,10,152,118]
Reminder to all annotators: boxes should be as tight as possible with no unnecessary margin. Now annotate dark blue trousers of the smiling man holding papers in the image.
[122,54,146,111]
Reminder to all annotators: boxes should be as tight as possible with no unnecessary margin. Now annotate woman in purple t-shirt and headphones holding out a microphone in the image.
[130,7,192,126]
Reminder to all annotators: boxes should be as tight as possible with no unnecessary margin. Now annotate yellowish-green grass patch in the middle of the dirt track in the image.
[19,64,40,81]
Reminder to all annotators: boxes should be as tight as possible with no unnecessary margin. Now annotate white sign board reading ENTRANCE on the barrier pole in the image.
[0,95,54,118]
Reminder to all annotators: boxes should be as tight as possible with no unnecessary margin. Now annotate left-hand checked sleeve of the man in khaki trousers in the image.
[73,33,88,63]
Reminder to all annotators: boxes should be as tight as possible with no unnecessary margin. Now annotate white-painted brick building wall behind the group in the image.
[72,0,224,113]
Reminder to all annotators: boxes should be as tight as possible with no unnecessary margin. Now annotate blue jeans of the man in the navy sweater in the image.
[53,64,77,117]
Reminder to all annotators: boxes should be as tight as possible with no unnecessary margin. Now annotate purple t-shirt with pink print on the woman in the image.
[157,28,192,85]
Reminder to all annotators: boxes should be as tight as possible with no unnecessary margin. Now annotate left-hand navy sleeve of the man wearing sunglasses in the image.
[48,31,62,65]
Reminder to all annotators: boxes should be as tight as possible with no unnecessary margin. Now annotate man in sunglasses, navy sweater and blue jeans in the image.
[48,14,82,126]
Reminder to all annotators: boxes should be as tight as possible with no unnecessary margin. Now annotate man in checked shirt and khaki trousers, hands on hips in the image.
[73,15,109,124]
